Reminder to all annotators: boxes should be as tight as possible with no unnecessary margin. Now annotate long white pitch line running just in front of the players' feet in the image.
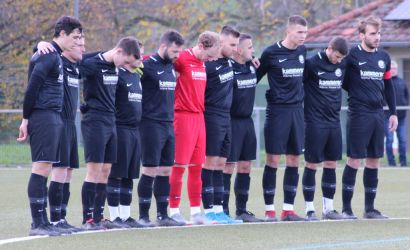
[0,217,410,246]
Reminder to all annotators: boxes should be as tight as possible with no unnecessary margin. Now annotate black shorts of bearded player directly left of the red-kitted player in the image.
[140,119,175,167]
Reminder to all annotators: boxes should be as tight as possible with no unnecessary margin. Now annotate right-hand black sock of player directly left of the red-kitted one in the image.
[154,176,169,217]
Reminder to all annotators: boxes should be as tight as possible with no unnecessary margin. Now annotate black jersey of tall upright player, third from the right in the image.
[256,42,306,105]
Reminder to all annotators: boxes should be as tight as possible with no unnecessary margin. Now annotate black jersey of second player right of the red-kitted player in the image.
[231,62,256,117]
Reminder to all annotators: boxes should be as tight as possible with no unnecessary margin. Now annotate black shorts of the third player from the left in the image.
[81,111,117,163]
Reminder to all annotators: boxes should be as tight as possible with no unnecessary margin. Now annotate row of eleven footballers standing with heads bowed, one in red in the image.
[18,13,397,236]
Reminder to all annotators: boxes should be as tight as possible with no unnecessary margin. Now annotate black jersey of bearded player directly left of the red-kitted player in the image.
[141,54,176,122]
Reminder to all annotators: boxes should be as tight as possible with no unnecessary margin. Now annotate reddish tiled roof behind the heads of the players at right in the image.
[305,0,410,48]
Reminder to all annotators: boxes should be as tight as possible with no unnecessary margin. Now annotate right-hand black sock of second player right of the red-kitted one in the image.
[234,173,251,215]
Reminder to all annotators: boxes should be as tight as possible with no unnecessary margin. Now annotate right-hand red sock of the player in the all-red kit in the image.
[187,165,202,207]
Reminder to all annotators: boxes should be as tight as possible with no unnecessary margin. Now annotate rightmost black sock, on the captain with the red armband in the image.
[363,167,379,212]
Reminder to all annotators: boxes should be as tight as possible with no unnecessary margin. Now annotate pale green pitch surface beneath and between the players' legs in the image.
[0,165,410,249]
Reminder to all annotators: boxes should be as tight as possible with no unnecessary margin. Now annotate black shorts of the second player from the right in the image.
[305,123,342,163]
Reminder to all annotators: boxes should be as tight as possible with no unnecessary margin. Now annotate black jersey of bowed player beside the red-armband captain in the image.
[303,51,346,127]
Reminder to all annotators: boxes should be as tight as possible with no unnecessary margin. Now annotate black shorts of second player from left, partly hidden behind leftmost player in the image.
[53,120,79,168]
